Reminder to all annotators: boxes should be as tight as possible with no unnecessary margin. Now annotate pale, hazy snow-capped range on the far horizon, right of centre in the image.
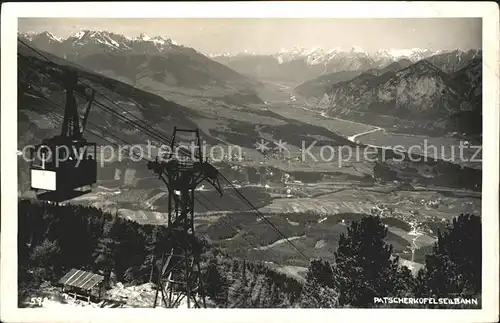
[209,47,482,83]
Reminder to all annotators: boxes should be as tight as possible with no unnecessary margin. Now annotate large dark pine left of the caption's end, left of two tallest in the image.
[334,216,398,307]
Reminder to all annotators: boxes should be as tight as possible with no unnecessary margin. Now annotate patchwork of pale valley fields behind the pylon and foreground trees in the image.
[44,165,481,272]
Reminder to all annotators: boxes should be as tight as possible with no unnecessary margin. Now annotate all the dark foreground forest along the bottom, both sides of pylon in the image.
[18,200,481,308]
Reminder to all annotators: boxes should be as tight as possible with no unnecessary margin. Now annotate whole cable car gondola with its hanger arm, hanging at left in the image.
[30,71,97,202]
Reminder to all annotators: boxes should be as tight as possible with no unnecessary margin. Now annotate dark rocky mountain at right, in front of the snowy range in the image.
[320,59,482,134]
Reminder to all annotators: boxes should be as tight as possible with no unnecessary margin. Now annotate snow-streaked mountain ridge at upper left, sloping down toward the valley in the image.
[18,30,261,96]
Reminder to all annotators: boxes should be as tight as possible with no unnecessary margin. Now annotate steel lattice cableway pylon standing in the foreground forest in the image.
[148,127,222,308]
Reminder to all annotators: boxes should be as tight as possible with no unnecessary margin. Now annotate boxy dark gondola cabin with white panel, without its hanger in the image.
[30,138,97,193]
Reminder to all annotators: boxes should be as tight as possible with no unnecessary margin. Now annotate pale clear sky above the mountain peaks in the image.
[19,18,482,54]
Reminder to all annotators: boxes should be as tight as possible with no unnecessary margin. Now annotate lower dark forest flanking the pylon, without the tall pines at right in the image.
[18,200,301,307]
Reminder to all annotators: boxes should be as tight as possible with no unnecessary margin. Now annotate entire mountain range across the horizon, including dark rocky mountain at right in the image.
[19,30,482,138]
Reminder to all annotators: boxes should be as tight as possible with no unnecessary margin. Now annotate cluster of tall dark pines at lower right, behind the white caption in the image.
[301,214,482,308]
